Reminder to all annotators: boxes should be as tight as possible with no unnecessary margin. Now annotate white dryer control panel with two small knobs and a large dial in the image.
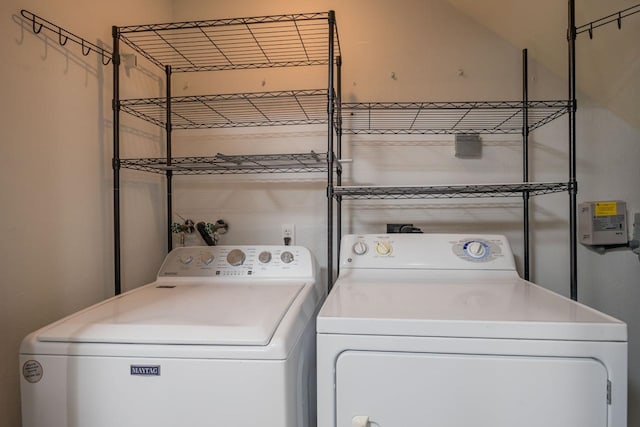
[340,234,515,270]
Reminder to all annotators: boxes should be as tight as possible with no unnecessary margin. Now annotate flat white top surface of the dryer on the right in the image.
[317,276,627,341]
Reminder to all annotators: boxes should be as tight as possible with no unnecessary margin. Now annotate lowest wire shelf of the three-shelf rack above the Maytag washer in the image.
[120,151,327,175]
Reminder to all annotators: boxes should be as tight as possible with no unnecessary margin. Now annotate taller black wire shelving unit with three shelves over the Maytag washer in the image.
[112,11,341,294]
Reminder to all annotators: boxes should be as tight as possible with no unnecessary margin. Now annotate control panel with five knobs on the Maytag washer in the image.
[158,246,314,278]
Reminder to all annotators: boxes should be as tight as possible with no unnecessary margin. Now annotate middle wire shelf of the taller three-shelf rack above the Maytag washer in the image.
[120,89,328,129]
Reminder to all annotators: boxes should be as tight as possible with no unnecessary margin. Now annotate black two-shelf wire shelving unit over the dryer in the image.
[329,47,577,290]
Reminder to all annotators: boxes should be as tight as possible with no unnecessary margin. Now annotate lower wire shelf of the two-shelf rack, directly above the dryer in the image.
[333,182,570,200]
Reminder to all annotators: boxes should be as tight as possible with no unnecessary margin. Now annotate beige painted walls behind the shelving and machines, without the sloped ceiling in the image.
[0,0,640,427]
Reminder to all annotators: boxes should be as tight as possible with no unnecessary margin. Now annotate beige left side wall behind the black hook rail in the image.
[0,0,172,427]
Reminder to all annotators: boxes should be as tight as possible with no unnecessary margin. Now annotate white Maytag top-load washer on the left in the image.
[20,246,326,427]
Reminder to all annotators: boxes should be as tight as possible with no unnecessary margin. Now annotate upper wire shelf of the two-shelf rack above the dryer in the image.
[342,101,571,135]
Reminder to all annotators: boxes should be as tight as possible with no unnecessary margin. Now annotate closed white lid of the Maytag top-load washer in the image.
[38,282,304,346]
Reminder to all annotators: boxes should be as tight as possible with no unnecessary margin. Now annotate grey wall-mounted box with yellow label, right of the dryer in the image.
[578,200,628,245]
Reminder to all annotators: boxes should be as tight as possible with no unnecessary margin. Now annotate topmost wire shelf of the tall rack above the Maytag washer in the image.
[117,11,340,72]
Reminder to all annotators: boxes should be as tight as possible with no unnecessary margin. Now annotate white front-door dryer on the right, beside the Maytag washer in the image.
[317,234,627,427]
